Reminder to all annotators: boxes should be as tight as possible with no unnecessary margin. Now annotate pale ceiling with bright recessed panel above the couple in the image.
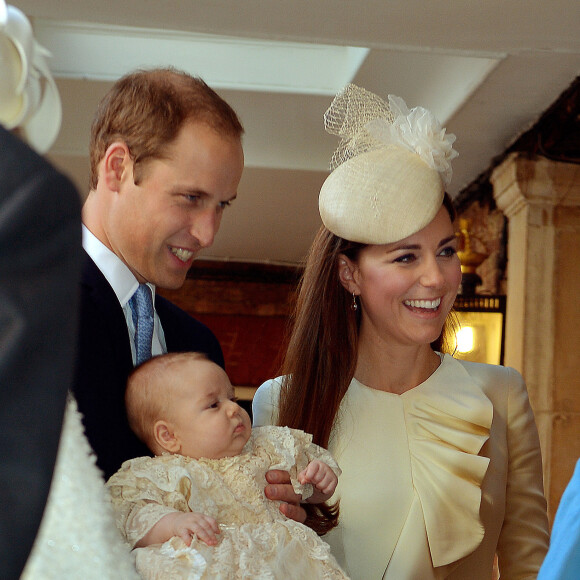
[17,0,580,263]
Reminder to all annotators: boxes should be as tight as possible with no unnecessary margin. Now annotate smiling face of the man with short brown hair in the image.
[105,123,244,289]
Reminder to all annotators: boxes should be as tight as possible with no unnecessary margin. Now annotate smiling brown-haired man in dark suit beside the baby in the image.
[73,69,243,477]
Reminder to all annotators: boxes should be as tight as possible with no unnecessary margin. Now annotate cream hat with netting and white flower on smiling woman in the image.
[318,84,458,244]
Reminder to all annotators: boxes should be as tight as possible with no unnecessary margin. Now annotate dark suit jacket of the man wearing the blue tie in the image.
[73,253,224,478]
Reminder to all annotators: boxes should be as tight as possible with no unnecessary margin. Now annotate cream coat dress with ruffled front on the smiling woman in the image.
[254,355,548,580]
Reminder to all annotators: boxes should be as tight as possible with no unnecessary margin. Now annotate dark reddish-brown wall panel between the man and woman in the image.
[159,261,300,396]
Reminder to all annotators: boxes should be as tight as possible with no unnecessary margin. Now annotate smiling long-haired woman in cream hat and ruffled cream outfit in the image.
[254,85,548,580]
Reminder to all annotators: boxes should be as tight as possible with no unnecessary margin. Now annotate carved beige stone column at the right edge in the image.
[491,153,580,518]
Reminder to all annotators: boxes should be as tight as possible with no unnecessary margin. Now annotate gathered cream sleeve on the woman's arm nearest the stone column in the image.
[497,369,549,580]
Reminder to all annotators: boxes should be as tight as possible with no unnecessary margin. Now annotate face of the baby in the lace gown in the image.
[167,360,252,459]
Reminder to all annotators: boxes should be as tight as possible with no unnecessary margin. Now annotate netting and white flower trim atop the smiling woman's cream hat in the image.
[324,84,458,185]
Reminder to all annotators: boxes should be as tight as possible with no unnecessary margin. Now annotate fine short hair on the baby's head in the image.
[125,352,209,453]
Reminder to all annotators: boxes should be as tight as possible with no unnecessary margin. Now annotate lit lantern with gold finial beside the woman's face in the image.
[450,218,506,364]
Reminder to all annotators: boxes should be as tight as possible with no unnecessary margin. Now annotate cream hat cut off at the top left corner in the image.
[0,0,62,153]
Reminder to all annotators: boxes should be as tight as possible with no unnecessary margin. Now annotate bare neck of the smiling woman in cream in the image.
[354,339,441,395]
